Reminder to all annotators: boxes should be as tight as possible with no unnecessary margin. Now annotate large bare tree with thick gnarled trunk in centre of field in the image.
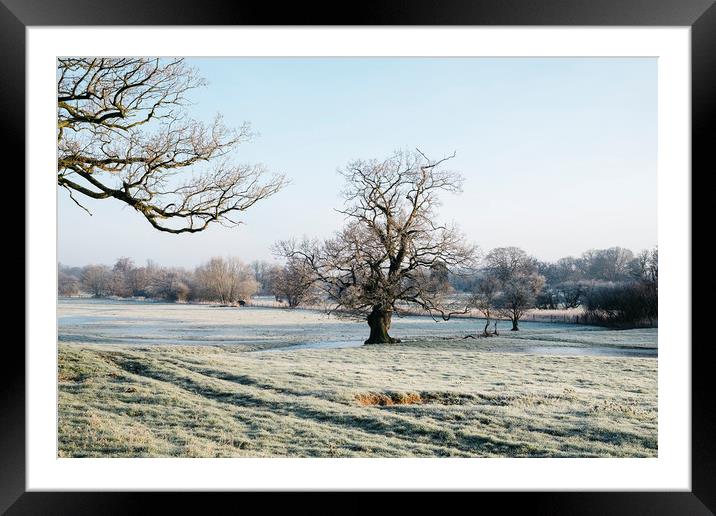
[278,151,475,344]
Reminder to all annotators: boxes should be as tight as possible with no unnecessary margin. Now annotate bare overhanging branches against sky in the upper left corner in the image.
[57,58,285,233]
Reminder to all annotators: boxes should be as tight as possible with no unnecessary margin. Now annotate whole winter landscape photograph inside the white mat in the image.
[57,55,656,462]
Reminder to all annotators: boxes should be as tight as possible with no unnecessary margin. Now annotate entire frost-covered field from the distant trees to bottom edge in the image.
[58,299,657,457]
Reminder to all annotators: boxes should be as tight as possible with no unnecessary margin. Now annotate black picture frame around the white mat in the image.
[5,0,716,515]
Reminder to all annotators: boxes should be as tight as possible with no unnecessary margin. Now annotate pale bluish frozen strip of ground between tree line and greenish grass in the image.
[58,299,656,356]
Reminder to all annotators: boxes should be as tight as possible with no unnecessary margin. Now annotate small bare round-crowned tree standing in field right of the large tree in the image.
[485,247,544,331]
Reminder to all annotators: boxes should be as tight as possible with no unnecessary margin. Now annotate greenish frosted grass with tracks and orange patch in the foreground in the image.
[58,332,657,457]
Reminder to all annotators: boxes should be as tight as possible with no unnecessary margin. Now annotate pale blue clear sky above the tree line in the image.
[58,58,657,267]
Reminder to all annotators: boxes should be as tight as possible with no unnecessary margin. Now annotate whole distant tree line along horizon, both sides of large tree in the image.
[58,241,659,328]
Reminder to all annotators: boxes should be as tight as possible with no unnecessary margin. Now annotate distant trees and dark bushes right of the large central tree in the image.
[462,247,659,335]
